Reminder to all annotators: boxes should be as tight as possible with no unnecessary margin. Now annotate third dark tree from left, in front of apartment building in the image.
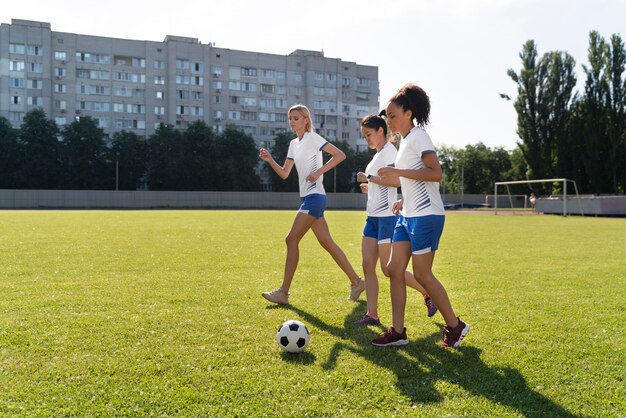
[61,116,109,190]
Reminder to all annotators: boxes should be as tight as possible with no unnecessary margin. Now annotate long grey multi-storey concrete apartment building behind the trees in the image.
[0,19,379,150]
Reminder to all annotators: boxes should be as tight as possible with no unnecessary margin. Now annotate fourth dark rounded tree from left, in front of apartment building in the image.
[109,131,148,190]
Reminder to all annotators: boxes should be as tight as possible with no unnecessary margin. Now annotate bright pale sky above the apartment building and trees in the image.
[0,0,626,150]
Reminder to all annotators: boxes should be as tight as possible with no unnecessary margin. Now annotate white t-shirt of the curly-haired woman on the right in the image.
[396,127,445,218]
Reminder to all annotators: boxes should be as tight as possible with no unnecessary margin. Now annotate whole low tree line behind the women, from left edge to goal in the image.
[0,109,526,194]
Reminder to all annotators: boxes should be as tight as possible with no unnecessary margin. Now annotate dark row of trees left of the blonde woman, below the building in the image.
[0,109,261,191]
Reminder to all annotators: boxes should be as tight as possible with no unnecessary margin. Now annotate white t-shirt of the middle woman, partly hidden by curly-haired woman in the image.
[365,142,398,217]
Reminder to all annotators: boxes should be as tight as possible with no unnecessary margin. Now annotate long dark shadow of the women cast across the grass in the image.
[285,301,576,417]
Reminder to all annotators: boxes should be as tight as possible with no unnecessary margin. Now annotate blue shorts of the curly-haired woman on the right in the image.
[393,215,446,255]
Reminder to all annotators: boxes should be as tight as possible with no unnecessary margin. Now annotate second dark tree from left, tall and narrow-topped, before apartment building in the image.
[17,108,61,189]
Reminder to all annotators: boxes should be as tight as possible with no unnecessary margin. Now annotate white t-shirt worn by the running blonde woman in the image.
[287,132,328,197]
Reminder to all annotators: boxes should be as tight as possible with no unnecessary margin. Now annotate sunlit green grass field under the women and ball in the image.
[0,211,626,417]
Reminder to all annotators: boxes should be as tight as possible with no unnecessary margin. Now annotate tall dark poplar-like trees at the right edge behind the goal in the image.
[501,31,626,194]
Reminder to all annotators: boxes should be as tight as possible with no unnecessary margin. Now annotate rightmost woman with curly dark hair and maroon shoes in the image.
[372,84,470,347]
